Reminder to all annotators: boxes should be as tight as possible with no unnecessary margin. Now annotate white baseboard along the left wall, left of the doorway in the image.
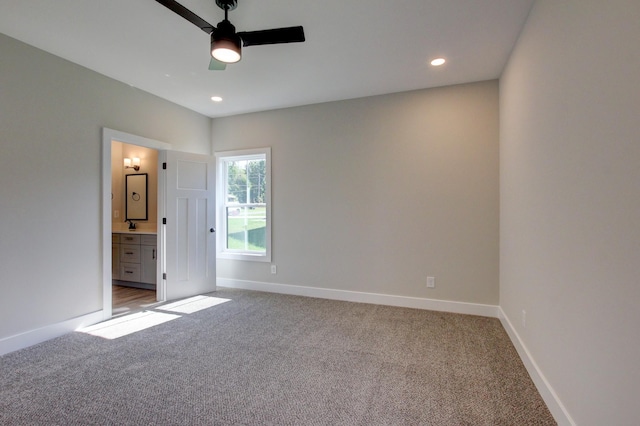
[0,311,104,355]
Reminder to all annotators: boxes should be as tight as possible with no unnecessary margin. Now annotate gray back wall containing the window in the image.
[212,81,499,305]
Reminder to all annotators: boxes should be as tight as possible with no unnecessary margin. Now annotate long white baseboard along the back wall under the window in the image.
[218,278,499,318]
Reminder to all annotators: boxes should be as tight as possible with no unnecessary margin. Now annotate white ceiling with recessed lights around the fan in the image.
[0,0,534,117]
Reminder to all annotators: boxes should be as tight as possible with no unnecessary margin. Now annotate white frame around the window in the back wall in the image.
[215,147,271,262]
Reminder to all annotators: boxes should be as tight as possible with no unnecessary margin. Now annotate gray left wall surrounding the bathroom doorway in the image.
[0,35,211,339]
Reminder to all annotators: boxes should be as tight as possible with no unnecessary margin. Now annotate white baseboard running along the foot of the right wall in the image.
[498,306,576,426]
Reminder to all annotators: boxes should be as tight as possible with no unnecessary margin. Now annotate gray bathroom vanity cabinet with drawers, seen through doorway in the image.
[111,232,158,290]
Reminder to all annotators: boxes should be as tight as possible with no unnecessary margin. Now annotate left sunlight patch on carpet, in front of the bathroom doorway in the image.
[78,311,180,340]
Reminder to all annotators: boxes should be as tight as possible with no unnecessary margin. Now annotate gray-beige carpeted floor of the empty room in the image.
[0,289,555,426]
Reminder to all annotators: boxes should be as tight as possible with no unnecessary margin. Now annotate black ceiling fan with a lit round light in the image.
[156,0,305,70]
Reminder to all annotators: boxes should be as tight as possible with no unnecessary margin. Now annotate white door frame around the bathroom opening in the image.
[102,127,171,320]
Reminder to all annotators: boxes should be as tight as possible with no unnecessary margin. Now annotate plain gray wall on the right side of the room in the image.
[500,0,640,425]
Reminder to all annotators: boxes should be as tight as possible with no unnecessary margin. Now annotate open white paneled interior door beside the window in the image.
[162,151,216,300]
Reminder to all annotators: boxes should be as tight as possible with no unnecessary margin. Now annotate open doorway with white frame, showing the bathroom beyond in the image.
[102,128,170,319]
